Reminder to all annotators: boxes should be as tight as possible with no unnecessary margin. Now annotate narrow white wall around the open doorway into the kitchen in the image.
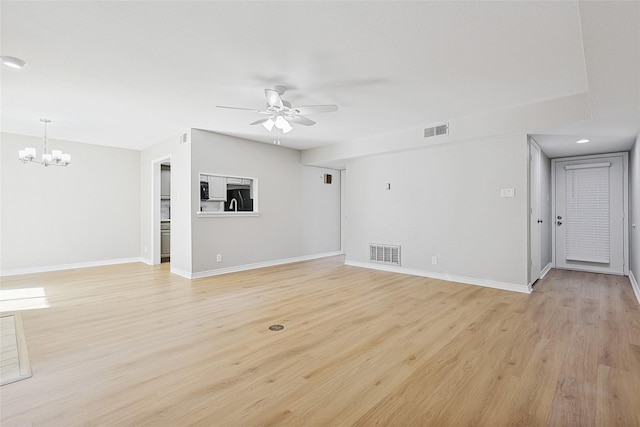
[139,131,191,274]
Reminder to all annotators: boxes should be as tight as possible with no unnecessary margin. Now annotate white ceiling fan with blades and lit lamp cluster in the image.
[217,86,338,138]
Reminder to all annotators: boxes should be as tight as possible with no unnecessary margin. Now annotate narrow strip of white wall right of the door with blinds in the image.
[629,135,640,290]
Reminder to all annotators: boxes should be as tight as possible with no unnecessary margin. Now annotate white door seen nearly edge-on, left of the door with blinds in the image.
[529,142,542,285]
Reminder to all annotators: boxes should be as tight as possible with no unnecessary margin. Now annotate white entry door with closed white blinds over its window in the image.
[554,156,624,274]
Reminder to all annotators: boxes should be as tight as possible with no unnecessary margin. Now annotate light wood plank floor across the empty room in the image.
[0,257,640,426]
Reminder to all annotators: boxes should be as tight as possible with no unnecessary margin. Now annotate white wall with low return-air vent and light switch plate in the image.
[345,135,528,289]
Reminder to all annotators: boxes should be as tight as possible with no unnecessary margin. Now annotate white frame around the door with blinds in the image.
[551,152,629,276]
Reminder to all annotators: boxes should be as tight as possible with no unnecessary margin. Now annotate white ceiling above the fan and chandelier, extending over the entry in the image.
[0,1,640,157]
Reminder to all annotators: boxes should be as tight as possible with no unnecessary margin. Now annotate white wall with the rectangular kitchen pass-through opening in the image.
[189,129,340,274]
